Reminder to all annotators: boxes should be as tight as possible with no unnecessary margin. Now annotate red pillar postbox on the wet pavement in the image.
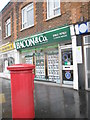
[7,64,35,118]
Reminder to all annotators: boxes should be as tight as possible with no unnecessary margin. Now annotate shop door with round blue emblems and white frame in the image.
[60,45,73,86]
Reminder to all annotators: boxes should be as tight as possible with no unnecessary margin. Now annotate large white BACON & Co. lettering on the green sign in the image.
[16,36,48,49]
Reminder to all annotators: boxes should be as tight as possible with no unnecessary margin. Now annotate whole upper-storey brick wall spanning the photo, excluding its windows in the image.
[2,0,90,43]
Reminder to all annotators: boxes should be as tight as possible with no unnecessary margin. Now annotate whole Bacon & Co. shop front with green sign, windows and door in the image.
[15,26,78,89]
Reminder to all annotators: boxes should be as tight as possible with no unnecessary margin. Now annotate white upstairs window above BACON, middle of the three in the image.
[22,3,34,29]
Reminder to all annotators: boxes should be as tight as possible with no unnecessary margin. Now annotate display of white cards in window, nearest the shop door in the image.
[47,52,60,83]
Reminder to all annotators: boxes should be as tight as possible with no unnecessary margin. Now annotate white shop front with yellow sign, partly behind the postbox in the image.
[0,42,17,78]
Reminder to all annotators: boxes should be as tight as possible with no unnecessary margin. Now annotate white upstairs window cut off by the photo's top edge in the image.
[47,0,60,19]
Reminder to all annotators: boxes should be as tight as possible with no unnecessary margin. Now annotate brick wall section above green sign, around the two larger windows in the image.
[17,2,89,39]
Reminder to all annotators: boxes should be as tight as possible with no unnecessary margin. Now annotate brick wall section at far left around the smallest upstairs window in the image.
[2,2,15,44]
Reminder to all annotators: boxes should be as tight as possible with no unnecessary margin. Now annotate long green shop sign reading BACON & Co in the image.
[15,26,71,50]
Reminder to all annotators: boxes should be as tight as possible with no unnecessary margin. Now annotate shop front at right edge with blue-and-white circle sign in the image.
[75,21,90,90]
